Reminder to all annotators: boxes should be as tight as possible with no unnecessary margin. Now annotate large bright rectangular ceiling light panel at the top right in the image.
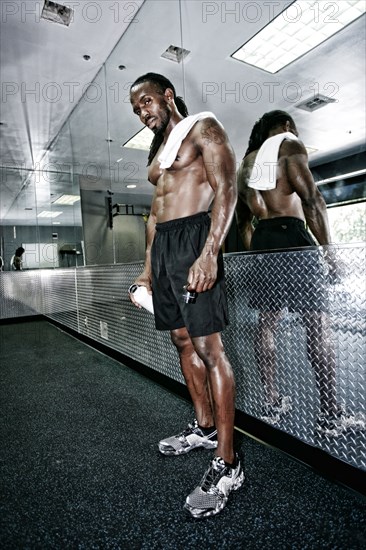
[232,0,366,73]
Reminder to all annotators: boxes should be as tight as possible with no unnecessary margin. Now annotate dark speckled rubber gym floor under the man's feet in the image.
[0,320,366,550]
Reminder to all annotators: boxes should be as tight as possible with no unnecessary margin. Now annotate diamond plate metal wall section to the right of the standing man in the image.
[223,245,366,469]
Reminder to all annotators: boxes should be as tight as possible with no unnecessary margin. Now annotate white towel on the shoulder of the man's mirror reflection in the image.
[248,132,298,191]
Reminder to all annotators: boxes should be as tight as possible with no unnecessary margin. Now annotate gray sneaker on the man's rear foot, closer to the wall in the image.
[159,420,217,456]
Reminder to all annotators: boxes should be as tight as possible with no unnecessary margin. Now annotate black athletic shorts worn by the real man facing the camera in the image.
[151,212,228,337]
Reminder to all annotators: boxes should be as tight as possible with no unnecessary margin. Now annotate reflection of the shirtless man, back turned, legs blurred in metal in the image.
[236,111,349,435]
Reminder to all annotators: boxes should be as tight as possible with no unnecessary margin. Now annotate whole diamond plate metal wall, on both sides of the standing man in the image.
[0,244,366,470]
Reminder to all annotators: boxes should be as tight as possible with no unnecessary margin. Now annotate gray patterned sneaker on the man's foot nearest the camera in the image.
[184,456,245,519]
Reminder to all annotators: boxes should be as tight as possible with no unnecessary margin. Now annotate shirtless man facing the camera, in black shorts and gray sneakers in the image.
[130,73,244,517]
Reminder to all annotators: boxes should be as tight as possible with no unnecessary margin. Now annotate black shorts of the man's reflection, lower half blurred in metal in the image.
[248,217,327,311]
